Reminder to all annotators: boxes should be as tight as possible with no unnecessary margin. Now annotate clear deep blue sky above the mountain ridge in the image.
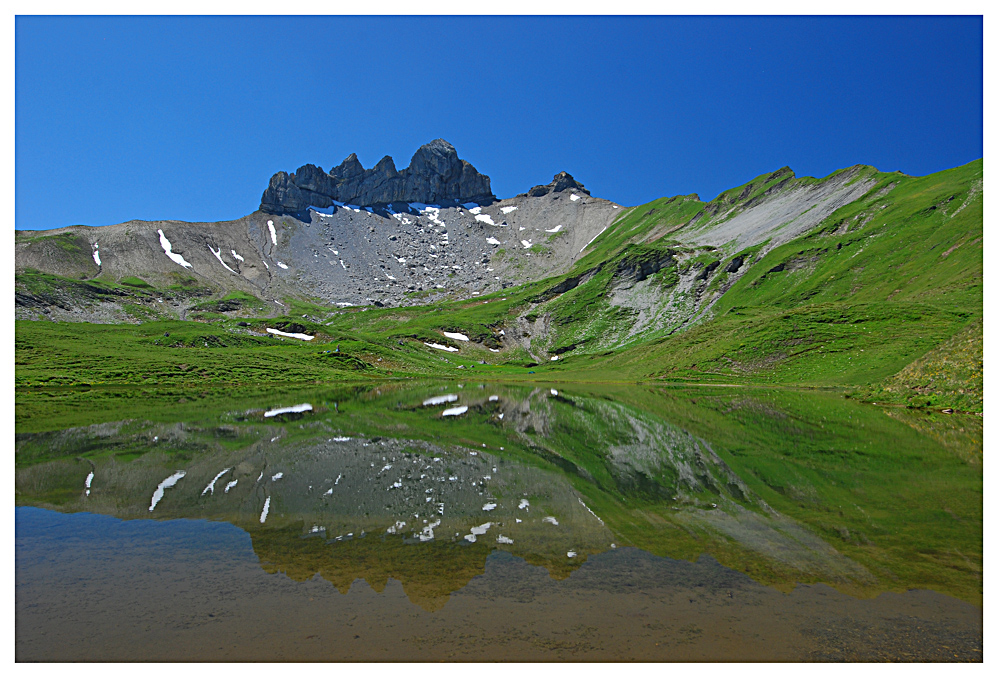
[15,16,983,229]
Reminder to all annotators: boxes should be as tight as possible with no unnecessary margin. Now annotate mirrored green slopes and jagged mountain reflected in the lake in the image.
[16,384,982,660]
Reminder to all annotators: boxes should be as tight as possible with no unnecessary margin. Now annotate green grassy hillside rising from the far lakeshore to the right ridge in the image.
[15,160,983,411]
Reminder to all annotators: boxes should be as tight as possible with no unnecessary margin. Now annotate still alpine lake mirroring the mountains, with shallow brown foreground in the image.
[15,381,983,662]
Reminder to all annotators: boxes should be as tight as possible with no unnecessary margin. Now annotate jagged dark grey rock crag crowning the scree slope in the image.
[260,139,496,214]
